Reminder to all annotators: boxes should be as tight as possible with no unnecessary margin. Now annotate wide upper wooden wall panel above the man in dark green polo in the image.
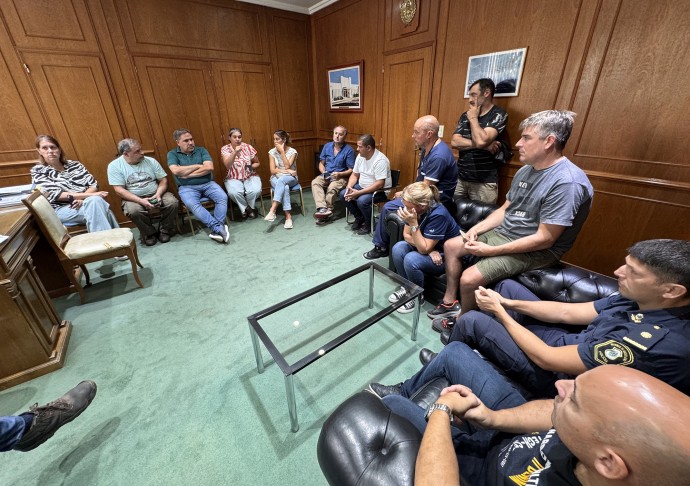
[117,0,270,62]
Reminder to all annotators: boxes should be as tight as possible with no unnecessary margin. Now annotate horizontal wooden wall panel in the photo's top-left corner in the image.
[0,0,98,52]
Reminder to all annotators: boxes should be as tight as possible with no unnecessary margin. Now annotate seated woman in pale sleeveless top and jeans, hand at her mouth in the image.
[264,130,297,229]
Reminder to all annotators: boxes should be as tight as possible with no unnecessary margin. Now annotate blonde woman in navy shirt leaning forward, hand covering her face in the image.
[388,182,460,314]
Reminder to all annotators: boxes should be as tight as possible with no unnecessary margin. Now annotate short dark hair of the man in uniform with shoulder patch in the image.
[628,239,690,293]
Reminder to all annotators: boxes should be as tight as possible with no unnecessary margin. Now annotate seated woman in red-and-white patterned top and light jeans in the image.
[220,128,261,219]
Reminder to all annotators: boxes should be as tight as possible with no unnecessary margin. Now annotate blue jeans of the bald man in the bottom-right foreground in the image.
[383,342,527,484]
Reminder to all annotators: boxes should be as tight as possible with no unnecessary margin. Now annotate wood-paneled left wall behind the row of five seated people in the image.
[0,0,316,221]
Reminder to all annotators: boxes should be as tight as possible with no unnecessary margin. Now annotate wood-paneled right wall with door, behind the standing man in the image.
[312,0,690,274]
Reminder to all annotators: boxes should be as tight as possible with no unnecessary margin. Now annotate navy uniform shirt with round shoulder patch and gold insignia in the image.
[564,293,690,395]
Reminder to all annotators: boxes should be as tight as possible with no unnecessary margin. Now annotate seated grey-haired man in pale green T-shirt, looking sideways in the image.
[108,138,177,246]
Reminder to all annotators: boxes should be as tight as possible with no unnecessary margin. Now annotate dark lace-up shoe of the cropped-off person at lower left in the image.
[14,381,96,452]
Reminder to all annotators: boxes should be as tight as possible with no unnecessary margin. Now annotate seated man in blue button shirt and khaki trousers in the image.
[311,125,355,225]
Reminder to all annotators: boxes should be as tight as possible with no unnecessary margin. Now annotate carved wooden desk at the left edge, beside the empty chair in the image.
[0,207,72,390]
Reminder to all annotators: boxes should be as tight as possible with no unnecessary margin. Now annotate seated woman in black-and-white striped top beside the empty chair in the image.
[31,135,119,232]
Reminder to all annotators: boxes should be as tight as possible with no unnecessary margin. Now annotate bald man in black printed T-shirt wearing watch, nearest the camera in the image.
[409,366,690,486]
